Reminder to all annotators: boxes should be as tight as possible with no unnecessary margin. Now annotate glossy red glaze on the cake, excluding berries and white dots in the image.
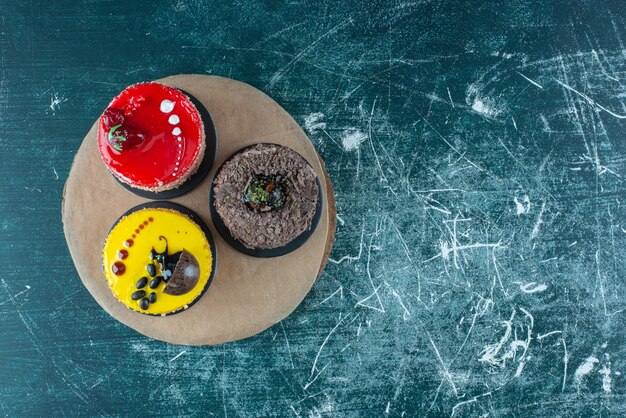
[98,83,203,188]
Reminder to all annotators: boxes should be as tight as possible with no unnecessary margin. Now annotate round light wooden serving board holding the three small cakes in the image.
[62,75,335,345]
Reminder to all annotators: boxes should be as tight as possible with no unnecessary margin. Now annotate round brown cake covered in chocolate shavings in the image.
[213,144,319,249]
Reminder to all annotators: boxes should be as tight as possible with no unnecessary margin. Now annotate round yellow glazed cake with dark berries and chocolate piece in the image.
[102,207,214,315]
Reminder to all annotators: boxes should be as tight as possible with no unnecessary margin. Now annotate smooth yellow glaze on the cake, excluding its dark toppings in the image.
[102,208,213,315]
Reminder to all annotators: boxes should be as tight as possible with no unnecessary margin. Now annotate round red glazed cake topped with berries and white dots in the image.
[98,83,206,193]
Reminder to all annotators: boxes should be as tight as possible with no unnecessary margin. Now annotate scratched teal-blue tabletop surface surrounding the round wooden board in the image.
[0,0,626,417]
